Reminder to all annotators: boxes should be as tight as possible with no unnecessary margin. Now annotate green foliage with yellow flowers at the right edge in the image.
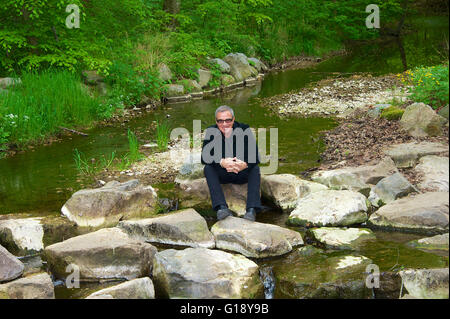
[398,64,449,110]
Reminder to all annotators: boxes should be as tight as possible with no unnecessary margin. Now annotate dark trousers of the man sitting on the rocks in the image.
[203,165,261,211]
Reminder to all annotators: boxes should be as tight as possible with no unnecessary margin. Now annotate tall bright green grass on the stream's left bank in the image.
[0,70,100,146]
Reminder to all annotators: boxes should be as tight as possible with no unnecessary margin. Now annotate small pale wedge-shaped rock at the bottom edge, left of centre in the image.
[86,277,155,299]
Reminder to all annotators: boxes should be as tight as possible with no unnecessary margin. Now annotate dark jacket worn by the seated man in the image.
[202,121,260,169]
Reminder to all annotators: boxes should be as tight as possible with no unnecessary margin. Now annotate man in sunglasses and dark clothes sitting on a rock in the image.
[202,105,261,221]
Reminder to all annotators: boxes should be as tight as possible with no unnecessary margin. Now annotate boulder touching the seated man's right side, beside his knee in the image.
[261,174,327,212]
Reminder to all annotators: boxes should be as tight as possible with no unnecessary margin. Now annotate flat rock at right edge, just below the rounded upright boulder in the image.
[384,142,448,168]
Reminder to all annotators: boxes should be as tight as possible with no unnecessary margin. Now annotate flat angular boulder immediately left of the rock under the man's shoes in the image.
[118,209,215,248]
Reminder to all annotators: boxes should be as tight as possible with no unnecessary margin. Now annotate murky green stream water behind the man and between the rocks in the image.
[0,18,448,298]
